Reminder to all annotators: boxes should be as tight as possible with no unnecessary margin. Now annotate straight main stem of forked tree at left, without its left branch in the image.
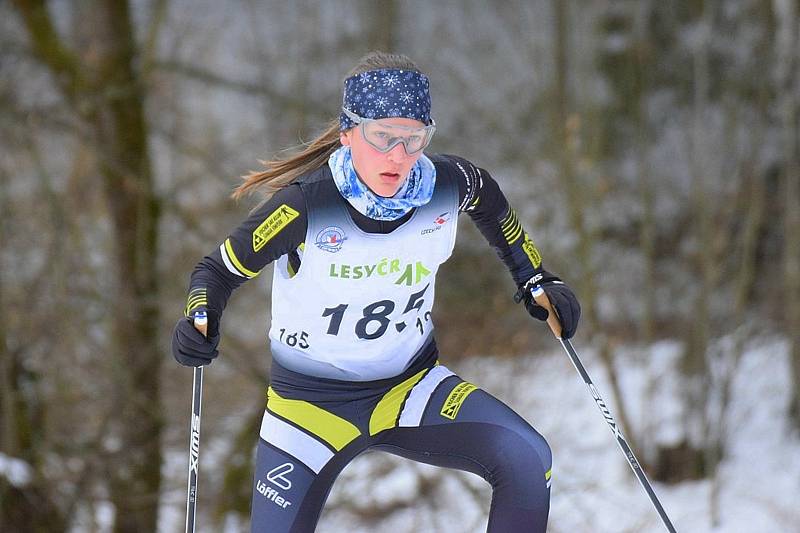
[88,0,163,533]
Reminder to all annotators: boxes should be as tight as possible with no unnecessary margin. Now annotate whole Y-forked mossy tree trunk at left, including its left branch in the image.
[16,0,163,533]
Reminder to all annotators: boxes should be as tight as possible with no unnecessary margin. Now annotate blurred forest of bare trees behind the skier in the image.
[0,0,800,533]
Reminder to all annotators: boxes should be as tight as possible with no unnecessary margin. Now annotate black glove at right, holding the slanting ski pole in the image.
[514,270,581,339]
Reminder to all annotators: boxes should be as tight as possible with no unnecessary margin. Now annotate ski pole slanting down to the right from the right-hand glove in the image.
[533,287,676,533]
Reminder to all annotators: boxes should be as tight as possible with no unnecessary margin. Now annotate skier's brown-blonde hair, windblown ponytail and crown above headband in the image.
[231,51,420,200]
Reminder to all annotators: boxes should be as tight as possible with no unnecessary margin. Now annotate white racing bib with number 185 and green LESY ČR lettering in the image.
[269,167,458,381]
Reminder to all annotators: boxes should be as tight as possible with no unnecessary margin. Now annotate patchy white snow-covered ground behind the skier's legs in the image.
[153,339,800,533]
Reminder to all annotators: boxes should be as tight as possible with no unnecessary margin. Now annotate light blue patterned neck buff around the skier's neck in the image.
[328,146,436,220]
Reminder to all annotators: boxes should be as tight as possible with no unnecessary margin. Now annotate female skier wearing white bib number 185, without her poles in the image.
[172,52,580,533]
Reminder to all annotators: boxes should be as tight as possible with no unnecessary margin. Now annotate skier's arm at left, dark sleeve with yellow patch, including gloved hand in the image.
[172,185,308,366]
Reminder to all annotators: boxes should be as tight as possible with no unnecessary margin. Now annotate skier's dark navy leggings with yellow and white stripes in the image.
[251,366,552,533]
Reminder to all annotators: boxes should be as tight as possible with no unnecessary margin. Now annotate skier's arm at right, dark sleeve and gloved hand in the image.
[450,156,581,339]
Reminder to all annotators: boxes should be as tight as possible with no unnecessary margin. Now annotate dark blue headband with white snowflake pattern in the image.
[339,68,431,131]
